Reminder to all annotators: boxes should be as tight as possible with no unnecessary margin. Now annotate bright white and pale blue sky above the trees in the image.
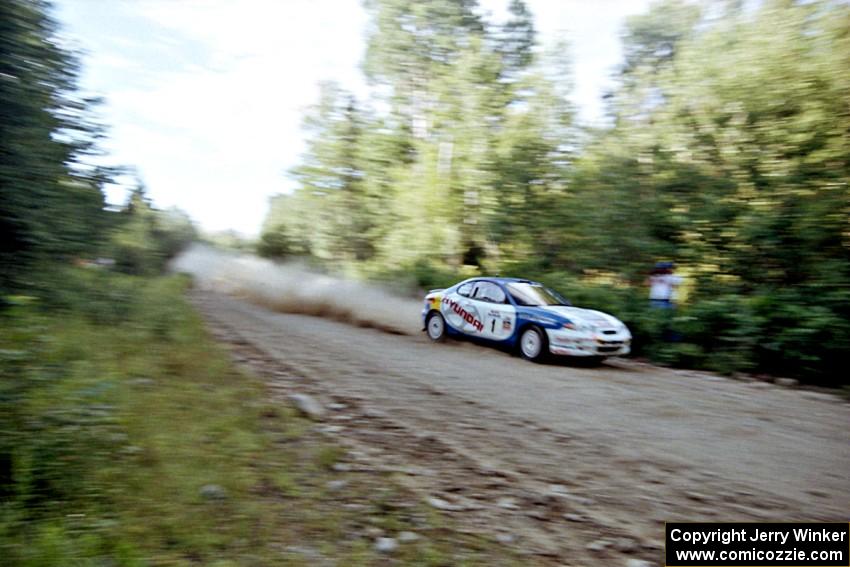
[55,0,649,235]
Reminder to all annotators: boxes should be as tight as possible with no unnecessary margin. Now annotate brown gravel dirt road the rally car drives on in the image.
[193,291,850,566]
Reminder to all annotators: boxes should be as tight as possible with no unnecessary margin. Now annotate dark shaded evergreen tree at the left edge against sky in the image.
[0,0,108,293]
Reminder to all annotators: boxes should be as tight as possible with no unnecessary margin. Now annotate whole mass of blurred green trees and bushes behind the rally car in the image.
[258,0,850,386]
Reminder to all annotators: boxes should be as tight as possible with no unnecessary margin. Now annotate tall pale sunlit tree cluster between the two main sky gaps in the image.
[263,0,576,276]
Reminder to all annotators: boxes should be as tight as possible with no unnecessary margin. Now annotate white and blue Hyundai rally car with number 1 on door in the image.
[422,277,632,361]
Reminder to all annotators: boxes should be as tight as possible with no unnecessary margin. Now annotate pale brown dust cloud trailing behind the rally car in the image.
[171,244,422,335]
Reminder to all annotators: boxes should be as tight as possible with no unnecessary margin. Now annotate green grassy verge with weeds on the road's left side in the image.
[0,269,517,567]
